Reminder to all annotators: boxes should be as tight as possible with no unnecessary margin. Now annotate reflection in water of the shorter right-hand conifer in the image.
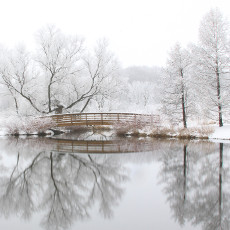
[161,142,189,225]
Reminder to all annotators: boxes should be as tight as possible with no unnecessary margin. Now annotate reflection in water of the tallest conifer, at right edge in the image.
[191,143,230,230]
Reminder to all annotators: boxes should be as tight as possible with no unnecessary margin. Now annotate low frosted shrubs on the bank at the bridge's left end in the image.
[5,116,55,135]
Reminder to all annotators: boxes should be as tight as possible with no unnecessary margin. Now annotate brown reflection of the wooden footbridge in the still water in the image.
[50,130,158,153]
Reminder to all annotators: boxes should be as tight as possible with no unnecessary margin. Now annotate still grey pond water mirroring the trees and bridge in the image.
[0,134,230,230]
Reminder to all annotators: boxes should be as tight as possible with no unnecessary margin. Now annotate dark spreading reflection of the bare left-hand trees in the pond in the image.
[0,143,128,229]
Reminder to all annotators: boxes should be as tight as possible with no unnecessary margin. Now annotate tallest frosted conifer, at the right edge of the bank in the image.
[193,9,230,126]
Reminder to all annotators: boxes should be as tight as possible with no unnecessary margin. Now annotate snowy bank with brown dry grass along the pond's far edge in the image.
[0,113,230,140]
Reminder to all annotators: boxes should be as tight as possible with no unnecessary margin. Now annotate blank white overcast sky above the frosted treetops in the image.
[0,0,230,67]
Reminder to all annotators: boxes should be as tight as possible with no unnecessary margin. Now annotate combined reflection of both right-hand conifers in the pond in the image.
[161,142,230,230]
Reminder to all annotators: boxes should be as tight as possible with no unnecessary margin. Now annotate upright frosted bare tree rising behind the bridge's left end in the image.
[35,26,83,112]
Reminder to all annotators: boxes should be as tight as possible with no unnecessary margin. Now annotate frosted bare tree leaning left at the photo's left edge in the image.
[0,46,40,112]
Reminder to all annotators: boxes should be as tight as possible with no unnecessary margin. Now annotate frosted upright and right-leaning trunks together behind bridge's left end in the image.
[36,27,118,112]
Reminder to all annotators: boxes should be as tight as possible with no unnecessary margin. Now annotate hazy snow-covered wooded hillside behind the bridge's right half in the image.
[120,66,162,113]
